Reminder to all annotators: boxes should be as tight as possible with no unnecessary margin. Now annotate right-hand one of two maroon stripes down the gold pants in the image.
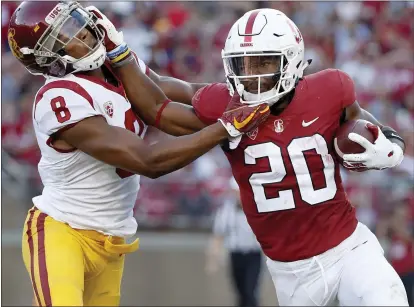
[36,213,52,306]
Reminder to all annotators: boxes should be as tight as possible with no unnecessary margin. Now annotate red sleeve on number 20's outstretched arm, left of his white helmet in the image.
[191,83,231,125]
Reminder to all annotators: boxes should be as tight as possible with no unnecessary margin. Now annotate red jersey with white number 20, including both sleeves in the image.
[193,69,357,262]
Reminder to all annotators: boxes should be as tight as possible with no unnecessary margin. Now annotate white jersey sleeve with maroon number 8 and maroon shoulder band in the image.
[33,81,102,135]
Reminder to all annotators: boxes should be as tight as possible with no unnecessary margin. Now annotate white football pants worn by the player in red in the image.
[267,223,408,306]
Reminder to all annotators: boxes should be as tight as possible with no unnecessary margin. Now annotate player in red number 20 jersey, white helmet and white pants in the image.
[102,9,408,306]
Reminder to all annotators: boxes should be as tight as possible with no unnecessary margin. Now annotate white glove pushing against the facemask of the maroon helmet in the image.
[85,6,128,61]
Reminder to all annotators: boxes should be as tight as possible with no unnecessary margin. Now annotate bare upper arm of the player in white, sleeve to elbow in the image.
[59,116,150,175]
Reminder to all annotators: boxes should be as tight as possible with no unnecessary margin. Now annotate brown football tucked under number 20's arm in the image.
[334,119,374,163]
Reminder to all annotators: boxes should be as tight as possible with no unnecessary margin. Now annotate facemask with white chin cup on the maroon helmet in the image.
[28,2,106,77]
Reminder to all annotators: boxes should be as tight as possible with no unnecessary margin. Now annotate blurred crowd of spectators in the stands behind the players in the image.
[1,1,414,282]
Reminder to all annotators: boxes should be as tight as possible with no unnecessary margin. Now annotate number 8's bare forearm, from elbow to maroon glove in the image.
[147,123,228,178]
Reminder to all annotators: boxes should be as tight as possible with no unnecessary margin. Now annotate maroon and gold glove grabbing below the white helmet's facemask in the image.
[218,84,270,137]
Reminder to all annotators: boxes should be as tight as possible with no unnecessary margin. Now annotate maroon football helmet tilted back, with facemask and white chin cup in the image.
[7,1,106,77]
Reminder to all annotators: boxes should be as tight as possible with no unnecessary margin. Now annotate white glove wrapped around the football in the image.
[343,124,404,170]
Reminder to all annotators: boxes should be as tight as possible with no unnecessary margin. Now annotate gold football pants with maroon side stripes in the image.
[22,207,139,306]
